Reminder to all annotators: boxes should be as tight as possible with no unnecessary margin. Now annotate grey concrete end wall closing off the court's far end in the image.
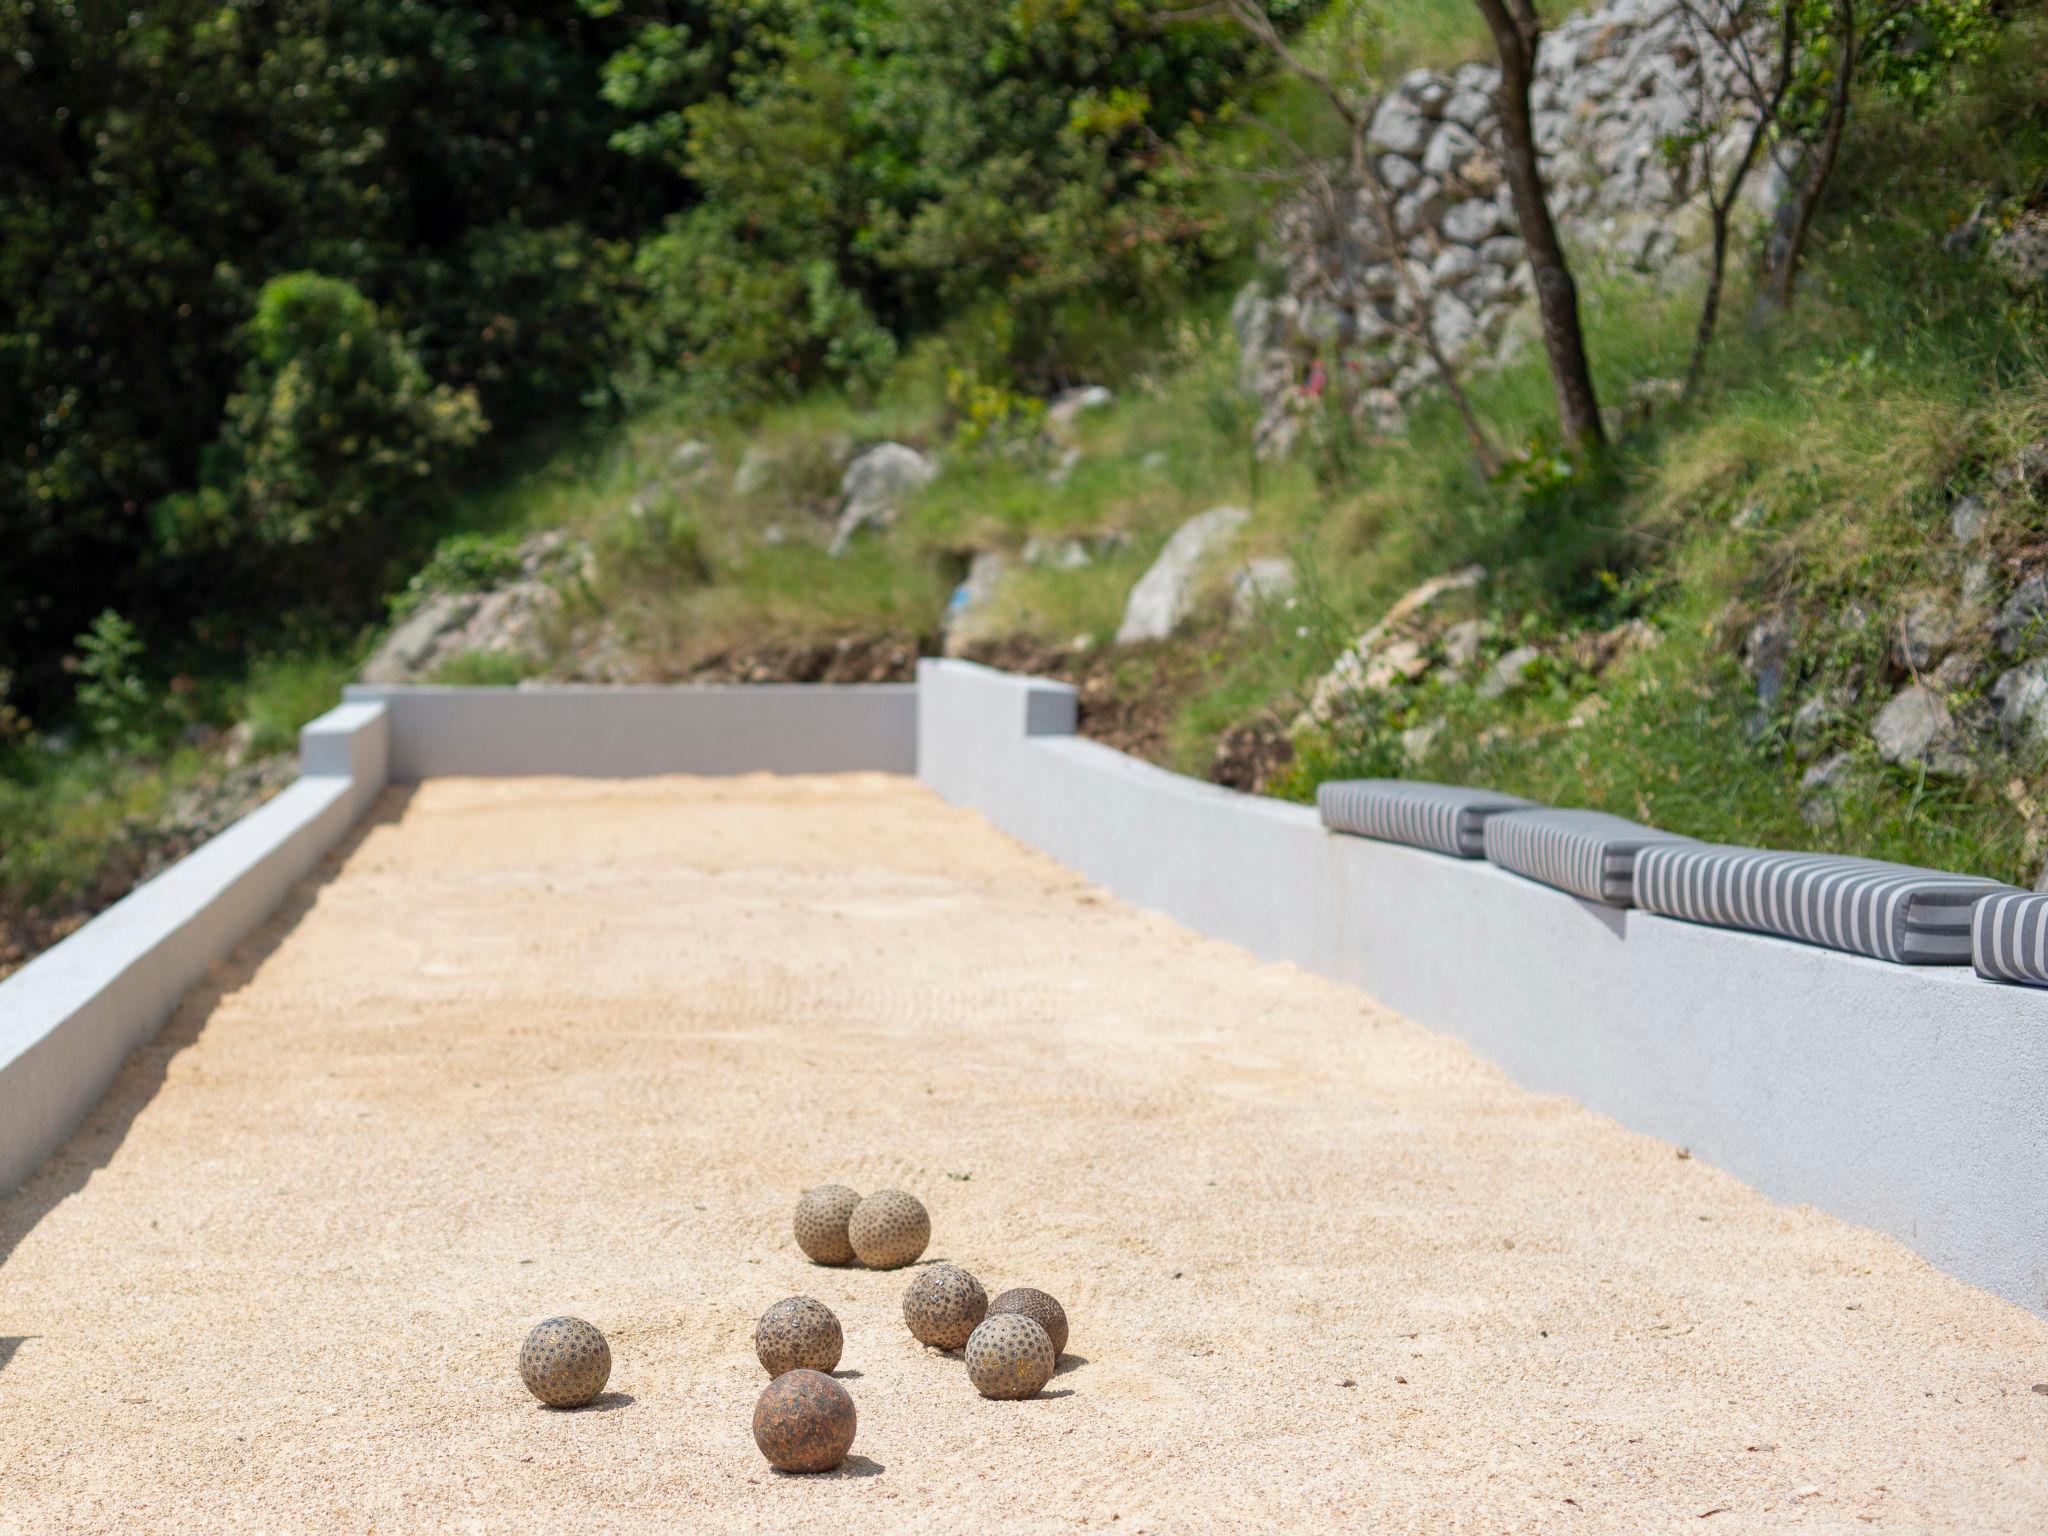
[346,682,918,782]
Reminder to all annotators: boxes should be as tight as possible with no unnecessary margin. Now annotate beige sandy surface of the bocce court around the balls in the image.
[0,776,2048,1536]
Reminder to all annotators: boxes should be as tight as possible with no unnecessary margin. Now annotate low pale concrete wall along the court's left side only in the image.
[0,705,391,1194]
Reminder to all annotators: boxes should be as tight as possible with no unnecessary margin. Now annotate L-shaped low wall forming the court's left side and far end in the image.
[0,684,918,1196]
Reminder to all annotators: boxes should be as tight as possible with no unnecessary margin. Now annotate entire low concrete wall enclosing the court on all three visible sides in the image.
[0,662,2048,1315]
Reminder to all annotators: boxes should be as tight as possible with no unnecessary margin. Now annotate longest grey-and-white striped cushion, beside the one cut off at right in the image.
[1636,844,2013,965]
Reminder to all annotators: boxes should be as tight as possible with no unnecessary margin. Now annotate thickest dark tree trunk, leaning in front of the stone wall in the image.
[1475,0,1608,449]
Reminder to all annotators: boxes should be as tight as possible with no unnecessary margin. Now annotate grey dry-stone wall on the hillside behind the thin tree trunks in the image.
[1231,0,1778,453]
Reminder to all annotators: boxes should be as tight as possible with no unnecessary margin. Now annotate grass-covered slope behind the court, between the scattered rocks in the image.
[12,12,2048,946]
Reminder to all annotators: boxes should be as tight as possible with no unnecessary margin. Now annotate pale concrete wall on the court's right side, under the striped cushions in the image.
[918,662,2048,1313]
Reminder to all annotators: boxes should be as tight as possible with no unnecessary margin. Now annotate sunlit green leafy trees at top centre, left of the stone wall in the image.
[592,0,1307,395]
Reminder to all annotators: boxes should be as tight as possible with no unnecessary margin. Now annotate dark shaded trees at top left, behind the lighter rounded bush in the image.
[0,0,659,719]
